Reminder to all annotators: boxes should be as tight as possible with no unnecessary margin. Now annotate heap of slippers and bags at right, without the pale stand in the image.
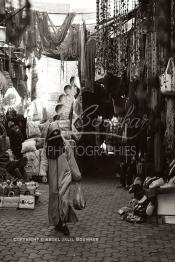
[118,176,175,223]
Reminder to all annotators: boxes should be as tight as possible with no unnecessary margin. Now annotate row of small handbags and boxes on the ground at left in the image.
[0,180,40,209]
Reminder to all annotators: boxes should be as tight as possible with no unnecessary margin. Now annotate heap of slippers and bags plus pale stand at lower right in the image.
[118,172,175,223]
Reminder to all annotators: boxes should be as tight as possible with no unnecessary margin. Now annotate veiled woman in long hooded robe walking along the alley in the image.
[46,121,81,235]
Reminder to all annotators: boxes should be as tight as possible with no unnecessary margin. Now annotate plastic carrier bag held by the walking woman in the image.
[73,183,86,210]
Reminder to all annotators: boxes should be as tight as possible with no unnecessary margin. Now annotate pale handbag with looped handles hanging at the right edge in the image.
[160,57,175,95]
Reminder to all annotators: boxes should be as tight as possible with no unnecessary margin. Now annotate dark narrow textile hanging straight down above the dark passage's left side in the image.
[85,38,96,92]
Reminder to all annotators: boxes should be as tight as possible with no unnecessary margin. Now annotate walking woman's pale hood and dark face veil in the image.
[46,121,65,159]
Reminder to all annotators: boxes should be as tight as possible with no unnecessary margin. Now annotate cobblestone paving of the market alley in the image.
[0,179,175,262]
